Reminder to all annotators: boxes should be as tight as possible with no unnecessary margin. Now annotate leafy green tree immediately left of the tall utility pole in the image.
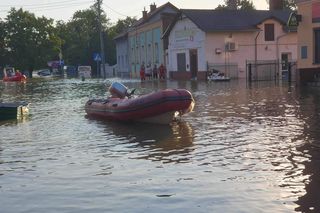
[56,6,110,75]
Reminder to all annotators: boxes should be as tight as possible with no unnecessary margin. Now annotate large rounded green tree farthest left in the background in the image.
[4,8,59,71]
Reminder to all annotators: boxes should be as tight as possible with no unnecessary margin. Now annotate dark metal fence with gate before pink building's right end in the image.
[246,60,297,81]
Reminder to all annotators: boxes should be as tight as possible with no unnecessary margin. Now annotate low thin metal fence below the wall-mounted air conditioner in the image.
[207,63,239,78]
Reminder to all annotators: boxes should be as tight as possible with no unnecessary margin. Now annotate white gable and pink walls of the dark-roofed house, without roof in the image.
[168,18,297,78]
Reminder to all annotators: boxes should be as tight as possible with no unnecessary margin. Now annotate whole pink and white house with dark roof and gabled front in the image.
[164,9,297,80]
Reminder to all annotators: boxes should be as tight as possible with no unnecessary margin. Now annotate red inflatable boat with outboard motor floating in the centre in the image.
[85,83,194,124]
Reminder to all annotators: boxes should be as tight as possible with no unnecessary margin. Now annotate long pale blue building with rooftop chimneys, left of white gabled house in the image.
[114,2,179,78]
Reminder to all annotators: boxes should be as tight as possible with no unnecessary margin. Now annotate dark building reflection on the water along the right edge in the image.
[292,88,320,212]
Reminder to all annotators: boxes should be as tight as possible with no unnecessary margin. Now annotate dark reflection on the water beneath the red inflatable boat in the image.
[89,118,194,163]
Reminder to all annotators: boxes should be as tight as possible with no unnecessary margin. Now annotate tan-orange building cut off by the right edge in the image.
[296,0,320,84]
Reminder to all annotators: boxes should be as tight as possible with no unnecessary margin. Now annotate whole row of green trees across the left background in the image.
[0,4,136,75]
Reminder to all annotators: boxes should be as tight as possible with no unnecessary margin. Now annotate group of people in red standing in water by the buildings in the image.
[140,64,166,81]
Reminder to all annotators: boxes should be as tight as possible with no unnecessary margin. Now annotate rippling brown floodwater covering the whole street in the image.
[0,79,320,213]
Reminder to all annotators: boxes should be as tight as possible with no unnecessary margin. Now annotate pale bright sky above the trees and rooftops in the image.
[0,0,268,23]
